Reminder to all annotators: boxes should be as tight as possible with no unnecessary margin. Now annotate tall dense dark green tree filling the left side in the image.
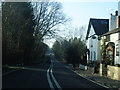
[2,2,35,64]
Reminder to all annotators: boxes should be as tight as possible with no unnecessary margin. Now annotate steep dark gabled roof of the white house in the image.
[86,18,109,39]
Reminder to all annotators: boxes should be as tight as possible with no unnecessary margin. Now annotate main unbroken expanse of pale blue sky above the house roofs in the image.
[61,2,118,27]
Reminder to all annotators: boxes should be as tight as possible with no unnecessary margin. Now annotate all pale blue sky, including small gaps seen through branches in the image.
[45,0,119,47]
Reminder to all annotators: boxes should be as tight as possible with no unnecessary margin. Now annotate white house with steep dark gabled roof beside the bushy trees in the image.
[86,18,109,62]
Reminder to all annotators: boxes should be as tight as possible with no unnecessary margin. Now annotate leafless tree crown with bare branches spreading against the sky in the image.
[33,1,67,40]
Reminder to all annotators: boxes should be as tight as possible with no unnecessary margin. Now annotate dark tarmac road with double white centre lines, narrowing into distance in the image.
[2,52,109,89]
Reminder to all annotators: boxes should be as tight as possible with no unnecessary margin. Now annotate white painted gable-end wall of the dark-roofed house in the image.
[87,26,100,61]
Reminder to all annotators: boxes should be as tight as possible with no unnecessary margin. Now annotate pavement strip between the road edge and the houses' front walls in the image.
[67,65,120,90]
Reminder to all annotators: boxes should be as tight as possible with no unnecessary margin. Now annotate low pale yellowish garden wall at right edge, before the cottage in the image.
[107,65,120,80]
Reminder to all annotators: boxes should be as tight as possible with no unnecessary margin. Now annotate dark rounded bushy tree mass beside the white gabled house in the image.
[53,37,86,64]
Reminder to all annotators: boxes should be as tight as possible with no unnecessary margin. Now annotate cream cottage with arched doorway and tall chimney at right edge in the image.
[101,9,120,65]
